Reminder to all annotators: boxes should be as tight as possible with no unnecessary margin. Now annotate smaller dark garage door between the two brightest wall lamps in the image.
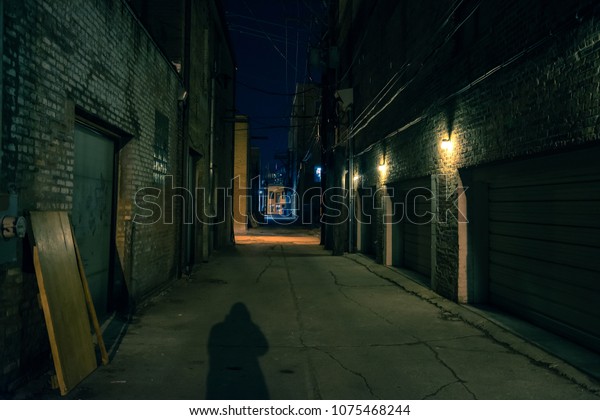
[388,178,432,284]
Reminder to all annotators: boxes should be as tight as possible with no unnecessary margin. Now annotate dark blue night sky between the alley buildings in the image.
[223,0,326,168]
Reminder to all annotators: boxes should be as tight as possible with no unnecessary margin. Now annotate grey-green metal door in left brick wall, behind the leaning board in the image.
[72,125,115,319]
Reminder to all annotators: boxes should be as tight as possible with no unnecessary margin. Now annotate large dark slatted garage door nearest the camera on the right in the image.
[488,149,600,350]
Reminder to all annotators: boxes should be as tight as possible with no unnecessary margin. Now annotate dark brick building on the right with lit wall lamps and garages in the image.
[330,0,600,350]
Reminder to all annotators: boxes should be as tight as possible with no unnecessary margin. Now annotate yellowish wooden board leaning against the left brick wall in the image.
[31,212,97,395]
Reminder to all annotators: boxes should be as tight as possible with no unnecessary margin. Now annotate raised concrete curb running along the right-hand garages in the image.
[344,254,600,396]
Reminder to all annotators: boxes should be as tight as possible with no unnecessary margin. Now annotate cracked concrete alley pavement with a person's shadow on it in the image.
[27,229,600,400]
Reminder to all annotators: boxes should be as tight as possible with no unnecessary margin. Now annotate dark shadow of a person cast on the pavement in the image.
[206,302,269,400]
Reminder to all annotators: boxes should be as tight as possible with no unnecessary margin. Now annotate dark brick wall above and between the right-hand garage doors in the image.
[339,0,600,299]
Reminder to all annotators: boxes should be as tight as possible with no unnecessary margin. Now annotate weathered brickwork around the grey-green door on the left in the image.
[0,0,182,392]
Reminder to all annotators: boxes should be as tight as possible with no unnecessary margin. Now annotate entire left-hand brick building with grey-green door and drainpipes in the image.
[0,0,233,393]
